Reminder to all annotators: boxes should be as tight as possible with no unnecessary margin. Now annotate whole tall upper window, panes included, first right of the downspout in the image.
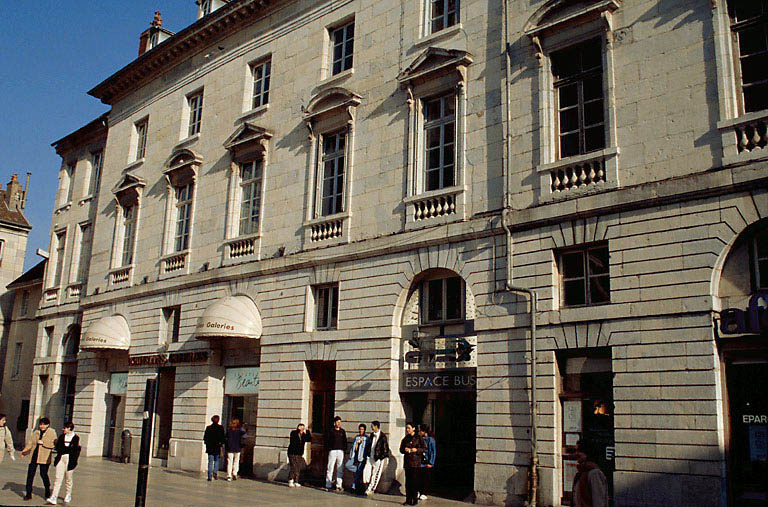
[552,39,605,159]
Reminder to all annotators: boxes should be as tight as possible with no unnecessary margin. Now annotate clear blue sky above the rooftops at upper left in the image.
[0,0,197,268]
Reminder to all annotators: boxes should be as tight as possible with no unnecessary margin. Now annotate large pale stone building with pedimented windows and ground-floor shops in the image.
[40,0,768,505]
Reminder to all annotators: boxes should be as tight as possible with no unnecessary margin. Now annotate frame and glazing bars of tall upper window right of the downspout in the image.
[549,37,608,160]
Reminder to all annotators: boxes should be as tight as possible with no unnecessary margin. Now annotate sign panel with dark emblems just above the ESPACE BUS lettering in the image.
[404,336,477,370]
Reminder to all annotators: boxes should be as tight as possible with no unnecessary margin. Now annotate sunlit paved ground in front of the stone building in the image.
[0,453,466,507]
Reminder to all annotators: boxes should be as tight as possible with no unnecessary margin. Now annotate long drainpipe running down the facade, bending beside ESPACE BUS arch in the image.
[501,0,539,507]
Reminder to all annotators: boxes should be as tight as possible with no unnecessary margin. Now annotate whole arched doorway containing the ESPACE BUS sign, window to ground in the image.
[400,269,477,499]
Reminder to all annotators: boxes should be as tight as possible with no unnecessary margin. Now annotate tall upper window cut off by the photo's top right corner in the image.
[728,0,768,113]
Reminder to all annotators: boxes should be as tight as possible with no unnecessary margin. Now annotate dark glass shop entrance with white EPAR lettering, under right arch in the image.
[726,358,768,507]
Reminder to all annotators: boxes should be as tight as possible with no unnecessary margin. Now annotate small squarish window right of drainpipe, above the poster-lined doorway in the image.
[559,245,611,306]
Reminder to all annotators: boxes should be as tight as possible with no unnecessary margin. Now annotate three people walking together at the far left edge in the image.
[0,414,81,505]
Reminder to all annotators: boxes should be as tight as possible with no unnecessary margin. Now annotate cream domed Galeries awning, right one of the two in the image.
[195,296,261,340]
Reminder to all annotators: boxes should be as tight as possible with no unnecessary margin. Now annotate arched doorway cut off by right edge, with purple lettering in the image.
[713,219,768,507]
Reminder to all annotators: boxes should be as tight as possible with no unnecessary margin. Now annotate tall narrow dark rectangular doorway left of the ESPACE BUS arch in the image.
[307,361,336,485]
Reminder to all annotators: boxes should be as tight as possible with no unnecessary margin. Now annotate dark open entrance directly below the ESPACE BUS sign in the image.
[404,392,477,500]
